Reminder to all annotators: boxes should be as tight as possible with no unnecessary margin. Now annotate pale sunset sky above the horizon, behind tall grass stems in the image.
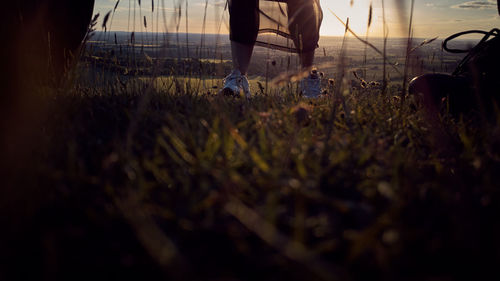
[94,0,500,38]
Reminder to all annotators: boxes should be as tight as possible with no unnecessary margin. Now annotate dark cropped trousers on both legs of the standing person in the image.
[229,0,321,53]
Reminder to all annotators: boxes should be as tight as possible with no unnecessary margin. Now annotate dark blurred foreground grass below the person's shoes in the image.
[0,75,500,280]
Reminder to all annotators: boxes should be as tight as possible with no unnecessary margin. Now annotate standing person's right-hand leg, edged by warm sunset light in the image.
[287,0,323,69]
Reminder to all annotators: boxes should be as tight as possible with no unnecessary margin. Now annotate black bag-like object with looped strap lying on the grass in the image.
[409,29,500,118]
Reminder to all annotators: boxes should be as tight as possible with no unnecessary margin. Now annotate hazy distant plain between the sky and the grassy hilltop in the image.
[84,32,468,85]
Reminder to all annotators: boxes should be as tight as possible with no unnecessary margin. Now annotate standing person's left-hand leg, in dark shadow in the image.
[229,0,259,75]
